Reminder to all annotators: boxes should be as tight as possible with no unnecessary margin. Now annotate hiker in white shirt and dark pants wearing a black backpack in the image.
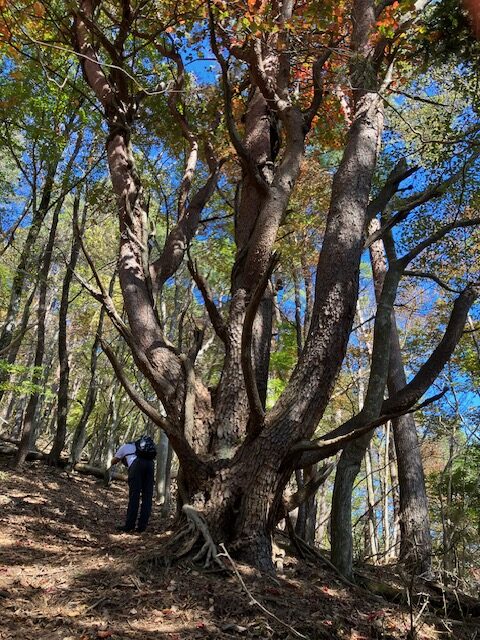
[112,436,157,533]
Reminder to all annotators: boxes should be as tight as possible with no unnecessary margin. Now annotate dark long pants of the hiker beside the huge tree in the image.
[125,458,154,530]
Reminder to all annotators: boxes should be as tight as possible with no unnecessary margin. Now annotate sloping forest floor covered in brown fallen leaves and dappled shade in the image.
[0,456,480,640]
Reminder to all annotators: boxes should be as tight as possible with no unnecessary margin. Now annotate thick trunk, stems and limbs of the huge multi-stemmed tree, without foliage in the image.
[71,0,476,570]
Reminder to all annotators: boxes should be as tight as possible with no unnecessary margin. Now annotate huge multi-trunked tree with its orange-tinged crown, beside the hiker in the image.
[30,0,478,570]
